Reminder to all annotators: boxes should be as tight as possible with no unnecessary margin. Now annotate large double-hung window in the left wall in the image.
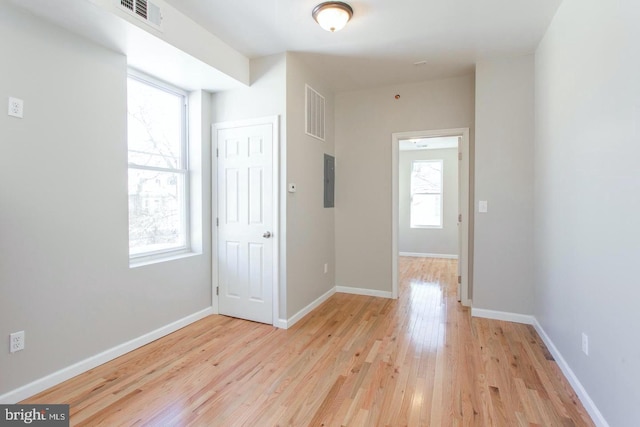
[127,73,189,258]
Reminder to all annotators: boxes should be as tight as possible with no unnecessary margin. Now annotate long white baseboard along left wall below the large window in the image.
[0,307,213,404]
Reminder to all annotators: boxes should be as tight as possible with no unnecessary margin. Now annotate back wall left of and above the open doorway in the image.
[335,75,474,293]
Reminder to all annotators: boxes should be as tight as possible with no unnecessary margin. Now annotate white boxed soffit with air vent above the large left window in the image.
[11,0,249,91]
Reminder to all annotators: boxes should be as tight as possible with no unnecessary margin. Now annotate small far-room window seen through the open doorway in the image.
[411,160,442,228]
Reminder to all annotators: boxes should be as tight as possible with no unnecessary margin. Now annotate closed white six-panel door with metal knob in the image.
[214,124,274,324]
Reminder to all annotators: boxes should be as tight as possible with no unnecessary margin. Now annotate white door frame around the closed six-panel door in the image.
[211,116,280,326]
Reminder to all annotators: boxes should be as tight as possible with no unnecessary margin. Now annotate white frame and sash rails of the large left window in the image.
[127,68,192,267]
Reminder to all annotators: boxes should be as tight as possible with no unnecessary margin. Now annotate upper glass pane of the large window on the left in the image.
[127,78,184,169]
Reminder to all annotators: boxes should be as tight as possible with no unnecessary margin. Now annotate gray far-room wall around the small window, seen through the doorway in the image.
[398,148,458,256]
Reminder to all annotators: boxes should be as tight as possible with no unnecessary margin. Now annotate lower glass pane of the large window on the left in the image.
[129,168,186,255]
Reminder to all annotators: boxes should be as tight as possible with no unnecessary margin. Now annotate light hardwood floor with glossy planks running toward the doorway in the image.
[28,258,593,426]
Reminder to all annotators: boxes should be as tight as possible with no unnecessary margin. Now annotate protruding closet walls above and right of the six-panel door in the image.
[213,53,339,320]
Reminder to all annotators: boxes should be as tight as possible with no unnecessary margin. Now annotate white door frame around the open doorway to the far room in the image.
[391,128,471,307]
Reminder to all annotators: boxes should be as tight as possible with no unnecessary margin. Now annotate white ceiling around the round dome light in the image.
[165,0,562,91]
